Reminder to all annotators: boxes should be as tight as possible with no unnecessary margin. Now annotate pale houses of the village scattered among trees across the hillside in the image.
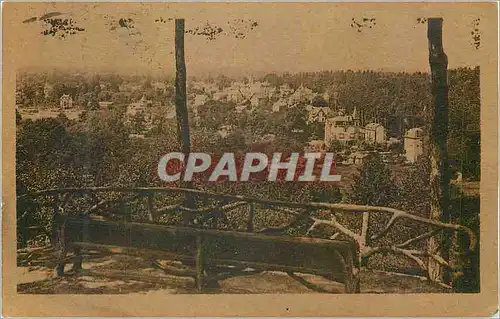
[16,73,423,166]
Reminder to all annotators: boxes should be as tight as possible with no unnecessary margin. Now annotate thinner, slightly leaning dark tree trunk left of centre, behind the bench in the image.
[175,19,194,226]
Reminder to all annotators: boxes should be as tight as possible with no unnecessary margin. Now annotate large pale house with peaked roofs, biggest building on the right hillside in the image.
[325,109,365,146]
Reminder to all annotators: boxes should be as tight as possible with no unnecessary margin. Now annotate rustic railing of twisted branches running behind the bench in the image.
[18,187,477,285]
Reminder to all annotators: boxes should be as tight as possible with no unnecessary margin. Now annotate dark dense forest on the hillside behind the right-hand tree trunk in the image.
[261,67,481,179]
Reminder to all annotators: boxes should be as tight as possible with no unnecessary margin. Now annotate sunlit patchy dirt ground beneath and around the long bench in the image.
[17,248,447,294]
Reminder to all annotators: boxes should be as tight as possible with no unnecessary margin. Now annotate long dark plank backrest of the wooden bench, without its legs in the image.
[64,218,358,282]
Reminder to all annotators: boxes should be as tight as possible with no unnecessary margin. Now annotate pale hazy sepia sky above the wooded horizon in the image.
[3,3,495,75]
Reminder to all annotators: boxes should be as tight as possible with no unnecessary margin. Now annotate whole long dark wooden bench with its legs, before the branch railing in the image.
[56,217,360,293]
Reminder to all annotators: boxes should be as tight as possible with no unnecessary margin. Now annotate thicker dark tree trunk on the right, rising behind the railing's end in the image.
[427,18,450,281]
